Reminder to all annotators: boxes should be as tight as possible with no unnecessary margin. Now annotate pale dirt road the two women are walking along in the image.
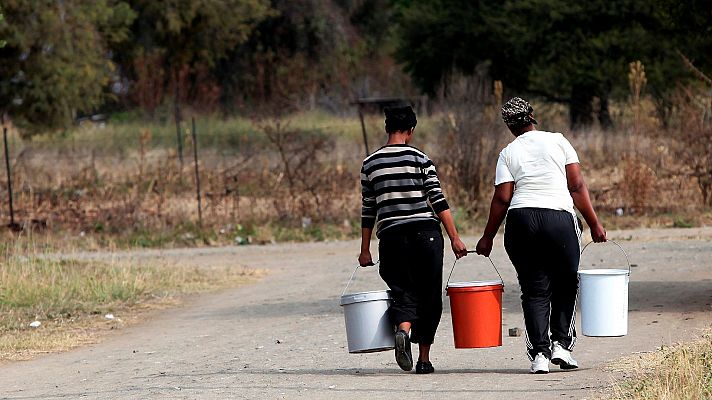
[0,228,712,400]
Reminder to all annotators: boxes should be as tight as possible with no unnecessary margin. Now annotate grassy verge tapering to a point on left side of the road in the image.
[0,244,259,362]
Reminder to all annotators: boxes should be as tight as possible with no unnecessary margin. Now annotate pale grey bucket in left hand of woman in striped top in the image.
[341,290,395,353]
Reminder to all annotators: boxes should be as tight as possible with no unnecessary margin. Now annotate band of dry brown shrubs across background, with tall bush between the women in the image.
[0,86,712,240]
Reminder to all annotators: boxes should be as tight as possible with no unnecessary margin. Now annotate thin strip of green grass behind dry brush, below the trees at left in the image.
[18,110,441,156]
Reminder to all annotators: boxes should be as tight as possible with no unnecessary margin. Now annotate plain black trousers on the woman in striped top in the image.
[378,222,443,344]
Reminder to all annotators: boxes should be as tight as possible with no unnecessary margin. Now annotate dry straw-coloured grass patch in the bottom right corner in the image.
[605,331,712,400]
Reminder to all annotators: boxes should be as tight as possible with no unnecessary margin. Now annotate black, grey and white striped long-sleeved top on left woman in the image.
[361,144,450,236]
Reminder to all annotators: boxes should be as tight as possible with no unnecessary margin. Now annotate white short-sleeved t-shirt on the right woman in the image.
[494,131,579,214]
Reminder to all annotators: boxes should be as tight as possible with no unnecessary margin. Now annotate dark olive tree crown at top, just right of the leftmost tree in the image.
[115,0,274,112]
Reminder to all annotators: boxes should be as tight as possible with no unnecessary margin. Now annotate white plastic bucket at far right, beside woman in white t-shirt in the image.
[578,242,630,336]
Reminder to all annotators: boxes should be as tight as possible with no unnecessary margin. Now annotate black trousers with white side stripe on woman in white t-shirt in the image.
[504,208,581,359]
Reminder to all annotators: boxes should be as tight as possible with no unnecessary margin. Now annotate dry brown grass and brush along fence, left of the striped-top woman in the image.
[0,118,363,231]
